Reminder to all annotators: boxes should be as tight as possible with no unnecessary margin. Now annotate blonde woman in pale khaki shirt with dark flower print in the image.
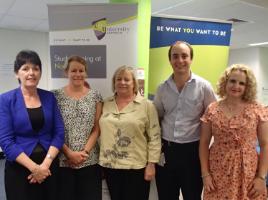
[99,66,161,200]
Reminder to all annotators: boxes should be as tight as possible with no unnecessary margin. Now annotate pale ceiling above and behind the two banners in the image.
[0,0,268,49]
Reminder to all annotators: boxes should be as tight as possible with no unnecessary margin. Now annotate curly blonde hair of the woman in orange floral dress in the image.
[216,64,257,102]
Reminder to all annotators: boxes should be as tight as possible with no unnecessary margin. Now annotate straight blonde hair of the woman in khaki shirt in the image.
[112,65,139,94]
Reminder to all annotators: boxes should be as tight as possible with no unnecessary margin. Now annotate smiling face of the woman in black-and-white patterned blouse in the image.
[66,61,87,87]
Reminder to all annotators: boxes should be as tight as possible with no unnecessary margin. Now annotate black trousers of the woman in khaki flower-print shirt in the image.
[103,168,150,200]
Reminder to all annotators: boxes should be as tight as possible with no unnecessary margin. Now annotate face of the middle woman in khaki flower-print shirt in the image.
[114,70,134,95]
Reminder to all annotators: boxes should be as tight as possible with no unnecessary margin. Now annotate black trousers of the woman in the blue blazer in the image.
[5,152,59,200]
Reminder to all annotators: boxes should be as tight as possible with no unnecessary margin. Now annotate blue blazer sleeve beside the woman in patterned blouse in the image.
[50,95,64,149]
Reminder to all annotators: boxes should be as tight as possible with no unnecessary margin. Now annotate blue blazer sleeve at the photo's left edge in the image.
[0,95,23,161]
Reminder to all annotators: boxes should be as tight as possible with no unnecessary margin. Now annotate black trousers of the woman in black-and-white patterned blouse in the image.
[60,165,102,200]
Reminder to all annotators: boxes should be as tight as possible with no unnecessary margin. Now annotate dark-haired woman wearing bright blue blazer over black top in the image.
[0,50,64,200]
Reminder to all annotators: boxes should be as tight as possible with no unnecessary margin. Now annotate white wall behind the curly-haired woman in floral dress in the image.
[228,47,268,105]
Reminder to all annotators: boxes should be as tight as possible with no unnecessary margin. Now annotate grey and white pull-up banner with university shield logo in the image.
[48,4,137,97]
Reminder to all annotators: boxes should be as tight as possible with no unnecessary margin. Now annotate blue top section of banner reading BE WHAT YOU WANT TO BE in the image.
[150,17,232,48]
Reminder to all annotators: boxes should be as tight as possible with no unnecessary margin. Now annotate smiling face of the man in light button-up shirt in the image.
[170,43,192,75]
